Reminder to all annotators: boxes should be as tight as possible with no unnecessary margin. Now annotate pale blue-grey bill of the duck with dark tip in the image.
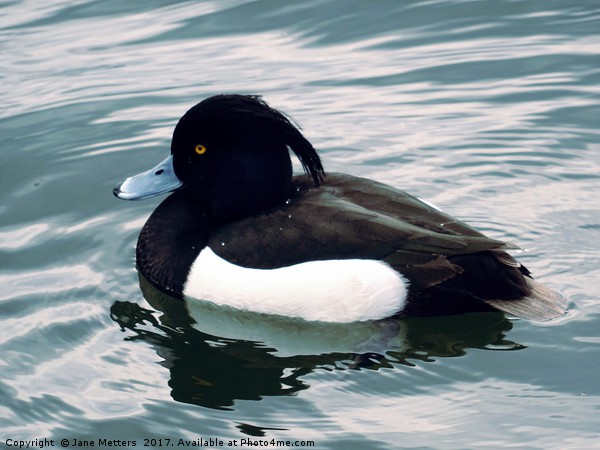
[113,155,183,200]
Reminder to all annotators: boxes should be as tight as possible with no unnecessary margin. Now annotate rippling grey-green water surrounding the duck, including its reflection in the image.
[0,0,600,449]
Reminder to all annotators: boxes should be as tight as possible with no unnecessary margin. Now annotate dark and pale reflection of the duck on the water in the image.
[111,275,523,409]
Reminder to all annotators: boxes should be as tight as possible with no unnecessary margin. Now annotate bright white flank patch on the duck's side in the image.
[184,247,408,323]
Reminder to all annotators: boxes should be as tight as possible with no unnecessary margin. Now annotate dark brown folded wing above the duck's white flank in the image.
[209,174,507,286]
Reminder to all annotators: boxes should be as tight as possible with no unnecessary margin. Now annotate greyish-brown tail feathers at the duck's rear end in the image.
[485,277,567,322]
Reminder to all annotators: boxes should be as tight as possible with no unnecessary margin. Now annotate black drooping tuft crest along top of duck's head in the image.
[180,94,325,186]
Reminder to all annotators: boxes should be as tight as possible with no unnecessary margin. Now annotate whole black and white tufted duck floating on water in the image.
[113,94,567,323]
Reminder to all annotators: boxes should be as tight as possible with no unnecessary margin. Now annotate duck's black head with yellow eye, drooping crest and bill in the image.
[114,95,324,220]
